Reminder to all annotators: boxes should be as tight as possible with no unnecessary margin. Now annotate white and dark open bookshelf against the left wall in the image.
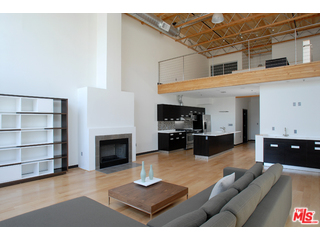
[0,94,68,187]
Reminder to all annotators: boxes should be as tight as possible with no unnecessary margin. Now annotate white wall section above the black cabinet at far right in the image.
[260,77,320,136]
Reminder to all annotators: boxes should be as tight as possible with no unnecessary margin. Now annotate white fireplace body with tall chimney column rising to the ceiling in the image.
[78,13,136,171]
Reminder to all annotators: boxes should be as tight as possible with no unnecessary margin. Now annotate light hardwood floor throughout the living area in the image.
[0,142,320,227]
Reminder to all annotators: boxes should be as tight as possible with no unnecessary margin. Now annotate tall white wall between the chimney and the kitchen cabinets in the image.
[122,14,200,153]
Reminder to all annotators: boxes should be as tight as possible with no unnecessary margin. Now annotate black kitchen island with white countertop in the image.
[193,132,236,160]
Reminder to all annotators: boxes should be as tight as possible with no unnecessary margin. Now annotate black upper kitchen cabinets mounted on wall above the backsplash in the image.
[158,104,205,121]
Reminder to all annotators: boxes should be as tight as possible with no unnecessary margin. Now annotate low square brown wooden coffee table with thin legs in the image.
[108,181,188,218]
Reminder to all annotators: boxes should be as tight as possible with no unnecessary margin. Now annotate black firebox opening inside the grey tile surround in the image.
[100,138,129,169]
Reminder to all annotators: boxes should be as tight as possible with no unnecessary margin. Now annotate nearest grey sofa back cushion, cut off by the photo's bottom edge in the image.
[200,211,237,227]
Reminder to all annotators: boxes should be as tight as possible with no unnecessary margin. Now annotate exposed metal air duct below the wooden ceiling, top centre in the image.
[129,13,180,37]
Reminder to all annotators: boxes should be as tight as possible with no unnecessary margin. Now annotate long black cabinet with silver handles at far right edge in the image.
[264,138,320,168]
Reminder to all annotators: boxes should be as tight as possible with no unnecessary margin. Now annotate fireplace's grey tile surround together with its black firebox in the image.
[96,134,132,169]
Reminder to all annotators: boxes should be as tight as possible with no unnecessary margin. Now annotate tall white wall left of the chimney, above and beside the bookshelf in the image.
[0,13,97,165]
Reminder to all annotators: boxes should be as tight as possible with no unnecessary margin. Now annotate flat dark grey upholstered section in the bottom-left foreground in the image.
[0,196,145,227]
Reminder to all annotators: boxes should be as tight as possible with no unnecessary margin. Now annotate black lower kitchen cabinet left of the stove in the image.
[158,132,186,151]
